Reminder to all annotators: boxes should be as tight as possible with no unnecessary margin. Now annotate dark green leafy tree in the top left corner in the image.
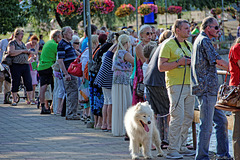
[0,0,28,34]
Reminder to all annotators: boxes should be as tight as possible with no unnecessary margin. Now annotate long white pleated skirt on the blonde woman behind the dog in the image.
[112,84,132,136]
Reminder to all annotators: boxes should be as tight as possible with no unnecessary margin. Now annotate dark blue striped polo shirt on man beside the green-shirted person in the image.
[57,39,77,69]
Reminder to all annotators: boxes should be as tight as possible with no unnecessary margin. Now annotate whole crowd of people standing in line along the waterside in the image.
[1,17,240,160]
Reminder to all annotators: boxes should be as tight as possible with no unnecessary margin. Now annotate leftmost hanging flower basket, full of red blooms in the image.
[57,1,75,16]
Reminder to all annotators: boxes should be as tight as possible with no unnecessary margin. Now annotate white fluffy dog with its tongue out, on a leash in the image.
[124,102,164,159]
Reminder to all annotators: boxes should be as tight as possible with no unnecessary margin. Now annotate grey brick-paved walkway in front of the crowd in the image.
[0,90,221,160]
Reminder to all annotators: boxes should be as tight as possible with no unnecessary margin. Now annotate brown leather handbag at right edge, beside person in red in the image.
[215,51,240,111]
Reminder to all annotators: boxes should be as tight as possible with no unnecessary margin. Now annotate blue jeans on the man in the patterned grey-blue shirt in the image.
[196,94,231,160]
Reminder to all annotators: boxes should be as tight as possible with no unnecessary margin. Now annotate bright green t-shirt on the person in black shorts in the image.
[37,39,58,71]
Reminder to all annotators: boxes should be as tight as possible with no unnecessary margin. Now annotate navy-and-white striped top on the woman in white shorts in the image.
[94,51,114,89]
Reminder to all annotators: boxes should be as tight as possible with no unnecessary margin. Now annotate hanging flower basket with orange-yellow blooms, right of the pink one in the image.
[115,4,135,17]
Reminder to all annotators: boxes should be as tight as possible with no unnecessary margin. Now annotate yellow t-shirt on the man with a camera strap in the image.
[159,39,192,87]
